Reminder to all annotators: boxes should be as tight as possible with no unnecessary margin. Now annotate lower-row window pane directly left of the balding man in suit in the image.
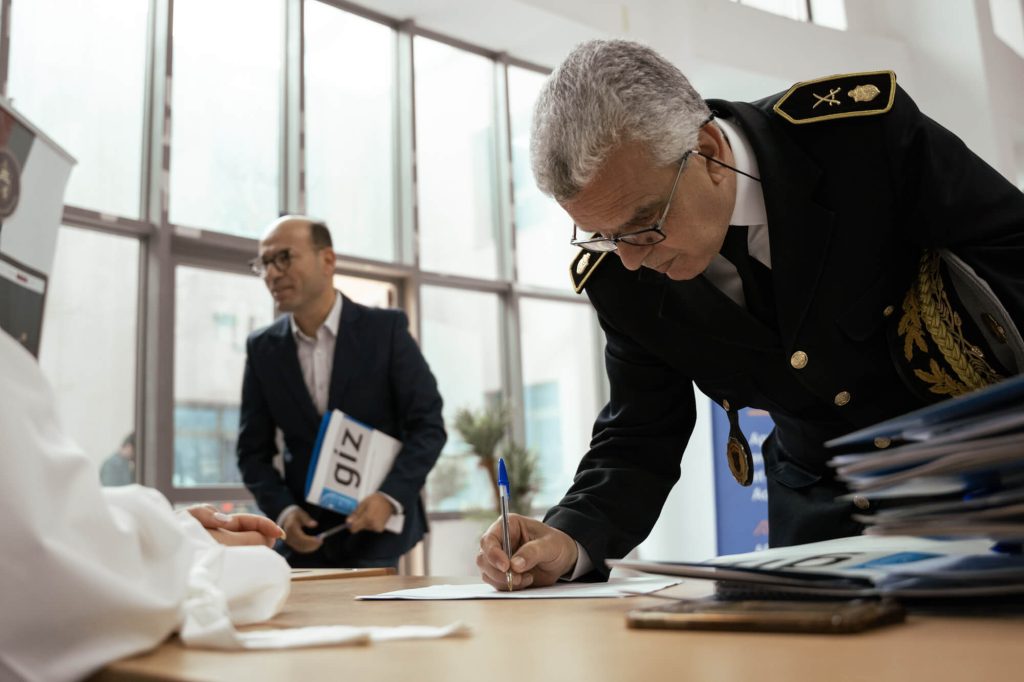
[173,266,273,487]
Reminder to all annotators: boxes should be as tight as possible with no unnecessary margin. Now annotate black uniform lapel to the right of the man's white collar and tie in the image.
[712,101,833,347]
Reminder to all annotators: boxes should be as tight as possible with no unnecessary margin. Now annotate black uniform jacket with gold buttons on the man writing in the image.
[545,77,1024,574]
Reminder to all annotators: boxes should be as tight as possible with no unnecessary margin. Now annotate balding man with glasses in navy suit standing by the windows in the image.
[238,216,447,567]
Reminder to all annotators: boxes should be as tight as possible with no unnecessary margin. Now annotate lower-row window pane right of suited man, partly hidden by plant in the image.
[420,287,502,511]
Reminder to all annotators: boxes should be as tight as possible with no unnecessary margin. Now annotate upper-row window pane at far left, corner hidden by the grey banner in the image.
[7,0,150,218]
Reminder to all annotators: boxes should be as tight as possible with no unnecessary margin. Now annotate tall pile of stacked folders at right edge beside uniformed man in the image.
[828,376,1024,543]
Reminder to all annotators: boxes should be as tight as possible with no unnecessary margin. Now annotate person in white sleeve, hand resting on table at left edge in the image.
[0,331,290,682]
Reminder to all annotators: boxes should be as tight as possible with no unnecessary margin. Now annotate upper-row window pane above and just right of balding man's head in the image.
[305,0,395,260]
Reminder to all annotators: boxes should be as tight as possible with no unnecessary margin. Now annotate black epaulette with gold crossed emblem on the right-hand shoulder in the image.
[772,71,896,125]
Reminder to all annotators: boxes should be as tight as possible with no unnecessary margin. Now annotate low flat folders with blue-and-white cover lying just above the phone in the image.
[607,536,1024,600]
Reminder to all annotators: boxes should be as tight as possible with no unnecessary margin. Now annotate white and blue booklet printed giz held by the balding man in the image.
[306,410,406,532]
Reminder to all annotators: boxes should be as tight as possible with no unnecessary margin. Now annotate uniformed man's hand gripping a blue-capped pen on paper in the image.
[476,514,577,592]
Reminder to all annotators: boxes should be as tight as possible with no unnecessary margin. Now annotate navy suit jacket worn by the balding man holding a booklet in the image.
[238,297,446,565]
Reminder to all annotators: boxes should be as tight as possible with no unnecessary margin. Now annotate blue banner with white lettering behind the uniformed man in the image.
[712,404,774,555]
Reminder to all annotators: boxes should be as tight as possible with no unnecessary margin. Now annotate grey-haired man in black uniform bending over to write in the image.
[477,41,1024,589]
